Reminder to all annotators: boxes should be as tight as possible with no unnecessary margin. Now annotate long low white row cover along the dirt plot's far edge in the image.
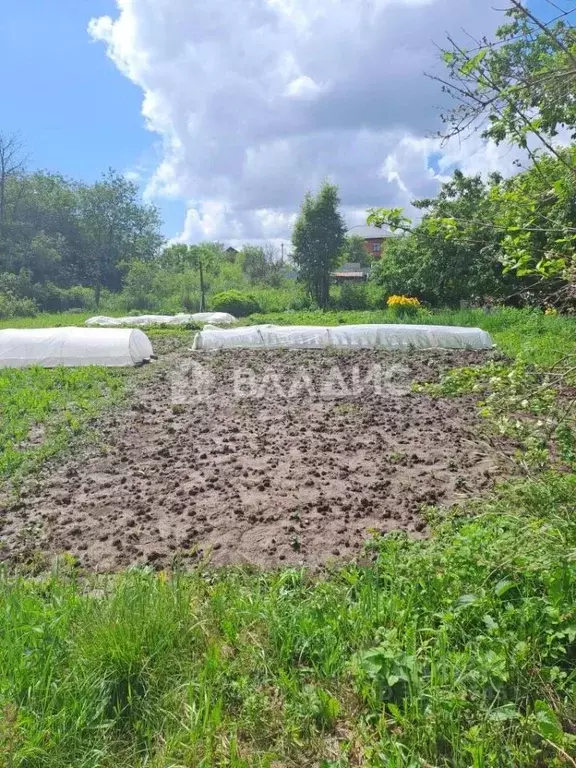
[193,324,494,349]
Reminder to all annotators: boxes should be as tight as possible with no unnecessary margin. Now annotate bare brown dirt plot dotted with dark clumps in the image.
[0,350,502,571]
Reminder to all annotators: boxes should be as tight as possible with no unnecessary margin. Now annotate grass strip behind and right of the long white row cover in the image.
[247,307,576,366]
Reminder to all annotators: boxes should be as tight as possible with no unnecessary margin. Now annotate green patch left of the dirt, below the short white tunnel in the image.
[0,366,126,482]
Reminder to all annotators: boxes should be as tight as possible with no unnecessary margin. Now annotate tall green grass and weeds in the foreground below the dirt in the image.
[0,476,576,768]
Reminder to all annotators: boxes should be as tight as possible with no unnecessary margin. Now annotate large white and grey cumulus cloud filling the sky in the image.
[89,0,506,242]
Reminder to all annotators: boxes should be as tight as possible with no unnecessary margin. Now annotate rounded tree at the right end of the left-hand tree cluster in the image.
[78,170,163,305]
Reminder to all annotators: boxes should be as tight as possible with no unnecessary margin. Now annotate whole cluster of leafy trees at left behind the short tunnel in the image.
[0,163,162,311]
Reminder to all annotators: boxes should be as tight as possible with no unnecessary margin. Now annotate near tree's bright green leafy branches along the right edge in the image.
[370,0,576,290]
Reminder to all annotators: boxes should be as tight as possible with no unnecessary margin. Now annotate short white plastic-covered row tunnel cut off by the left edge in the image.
[0,328,153,368]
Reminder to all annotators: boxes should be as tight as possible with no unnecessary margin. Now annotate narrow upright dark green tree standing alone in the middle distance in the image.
[292,182,346,309]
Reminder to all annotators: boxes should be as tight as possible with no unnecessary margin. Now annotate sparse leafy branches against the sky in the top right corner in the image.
[434,0,576,158]
